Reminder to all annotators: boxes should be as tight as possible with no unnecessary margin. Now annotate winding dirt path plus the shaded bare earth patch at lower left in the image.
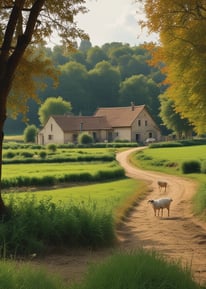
[32,148,206,283]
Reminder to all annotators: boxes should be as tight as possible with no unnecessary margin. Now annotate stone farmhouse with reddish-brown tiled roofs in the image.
[37,105,161,145]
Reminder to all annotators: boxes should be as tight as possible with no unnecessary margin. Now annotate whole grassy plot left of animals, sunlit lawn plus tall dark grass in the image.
[0,179,144,256]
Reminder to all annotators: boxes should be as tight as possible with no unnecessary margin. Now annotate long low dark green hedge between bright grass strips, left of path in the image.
[1,168,125,189]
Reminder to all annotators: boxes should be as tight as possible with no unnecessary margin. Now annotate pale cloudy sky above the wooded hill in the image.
[49,0,157,47]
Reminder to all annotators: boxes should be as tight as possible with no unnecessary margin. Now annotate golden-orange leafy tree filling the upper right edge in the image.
[136,0,206,134]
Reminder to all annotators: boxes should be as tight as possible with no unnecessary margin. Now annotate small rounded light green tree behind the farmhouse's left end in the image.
[38,96,72,125]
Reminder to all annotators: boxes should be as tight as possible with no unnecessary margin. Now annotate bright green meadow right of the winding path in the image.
[130,145,206,221]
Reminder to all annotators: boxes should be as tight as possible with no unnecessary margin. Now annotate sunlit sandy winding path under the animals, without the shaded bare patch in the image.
[117,148,206,283]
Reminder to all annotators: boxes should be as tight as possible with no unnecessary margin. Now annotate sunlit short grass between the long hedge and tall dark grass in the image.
[3,179,145,222]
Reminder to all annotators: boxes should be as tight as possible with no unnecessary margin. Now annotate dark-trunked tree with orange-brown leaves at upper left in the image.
[0,0,87,213]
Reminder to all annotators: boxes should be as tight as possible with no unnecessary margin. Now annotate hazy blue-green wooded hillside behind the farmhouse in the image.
[5,41,164,134]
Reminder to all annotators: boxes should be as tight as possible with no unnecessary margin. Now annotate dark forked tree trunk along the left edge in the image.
[0,0,45,215]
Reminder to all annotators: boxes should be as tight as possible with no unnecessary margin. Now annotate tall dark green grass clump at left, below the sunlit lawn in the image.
[0,195,115,256]
